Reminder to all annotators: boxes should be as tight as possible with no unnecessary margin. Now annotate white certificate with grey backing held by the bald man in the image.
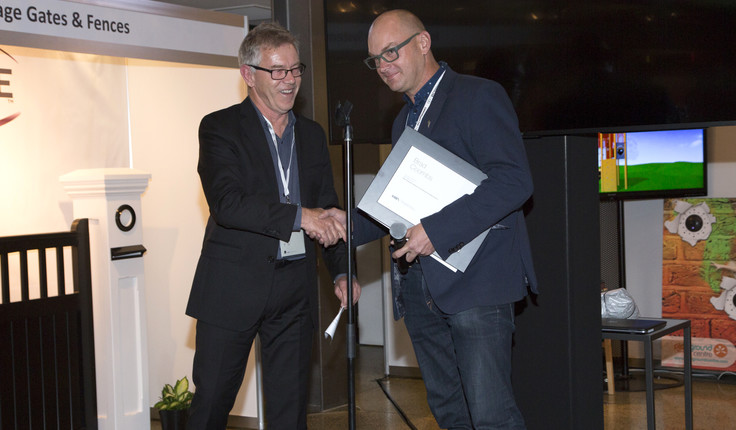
[358,127,488,271]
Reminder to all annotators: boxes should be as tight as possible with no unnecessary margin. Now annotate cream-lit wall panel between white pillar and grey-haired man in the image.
[128,60,257,417]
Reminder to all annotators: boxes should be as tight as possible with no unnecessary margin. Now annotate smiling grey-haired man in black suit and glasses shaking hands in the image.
[187,23,360,430]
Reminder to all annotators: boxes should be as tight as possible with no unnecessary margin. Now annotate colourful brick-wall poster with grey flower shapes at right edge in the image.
[662,198,736,371]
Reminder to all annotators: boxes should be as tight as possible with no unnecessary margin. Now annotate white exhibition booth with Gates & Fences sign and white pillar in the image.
[0,0,250,429]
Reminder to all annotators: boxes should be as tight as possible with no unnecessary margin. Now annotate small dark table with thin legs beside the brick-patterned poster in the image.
[602,318,693,430]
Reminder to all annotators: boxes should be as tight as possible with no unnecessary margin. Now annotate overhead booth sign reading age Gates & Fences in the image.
[0,0,247,67]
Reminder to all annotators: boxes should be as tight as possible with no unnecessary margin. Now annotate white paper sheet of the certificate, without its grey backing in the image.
[378,146,476,225]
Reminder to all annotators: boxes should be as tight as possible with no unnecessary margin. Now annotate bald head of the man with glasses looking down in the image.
[368,9,439,100]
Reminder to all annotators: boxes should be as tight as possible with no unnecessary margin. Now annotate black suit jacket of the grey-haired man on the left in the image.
[186,99,347,330]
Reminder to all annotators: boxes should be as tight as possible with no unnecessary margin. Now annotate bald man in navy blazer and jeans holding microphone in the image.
[353,10,536,429]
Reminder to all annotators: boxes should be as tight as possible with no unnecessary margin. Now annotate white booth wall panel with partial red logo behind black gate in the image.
[0,45,128,236]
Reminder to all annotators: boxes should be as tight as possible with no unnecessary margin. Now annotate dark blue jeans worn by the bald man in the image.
[401,265,525,429]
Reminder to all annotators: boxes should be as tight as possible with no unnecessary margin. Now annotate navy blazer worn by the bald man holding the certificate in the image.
[354,67,537,313]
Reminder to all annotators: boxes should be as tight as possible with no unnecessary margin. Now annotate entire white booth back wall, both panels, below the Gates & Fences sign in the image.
[0,46,257,417]
